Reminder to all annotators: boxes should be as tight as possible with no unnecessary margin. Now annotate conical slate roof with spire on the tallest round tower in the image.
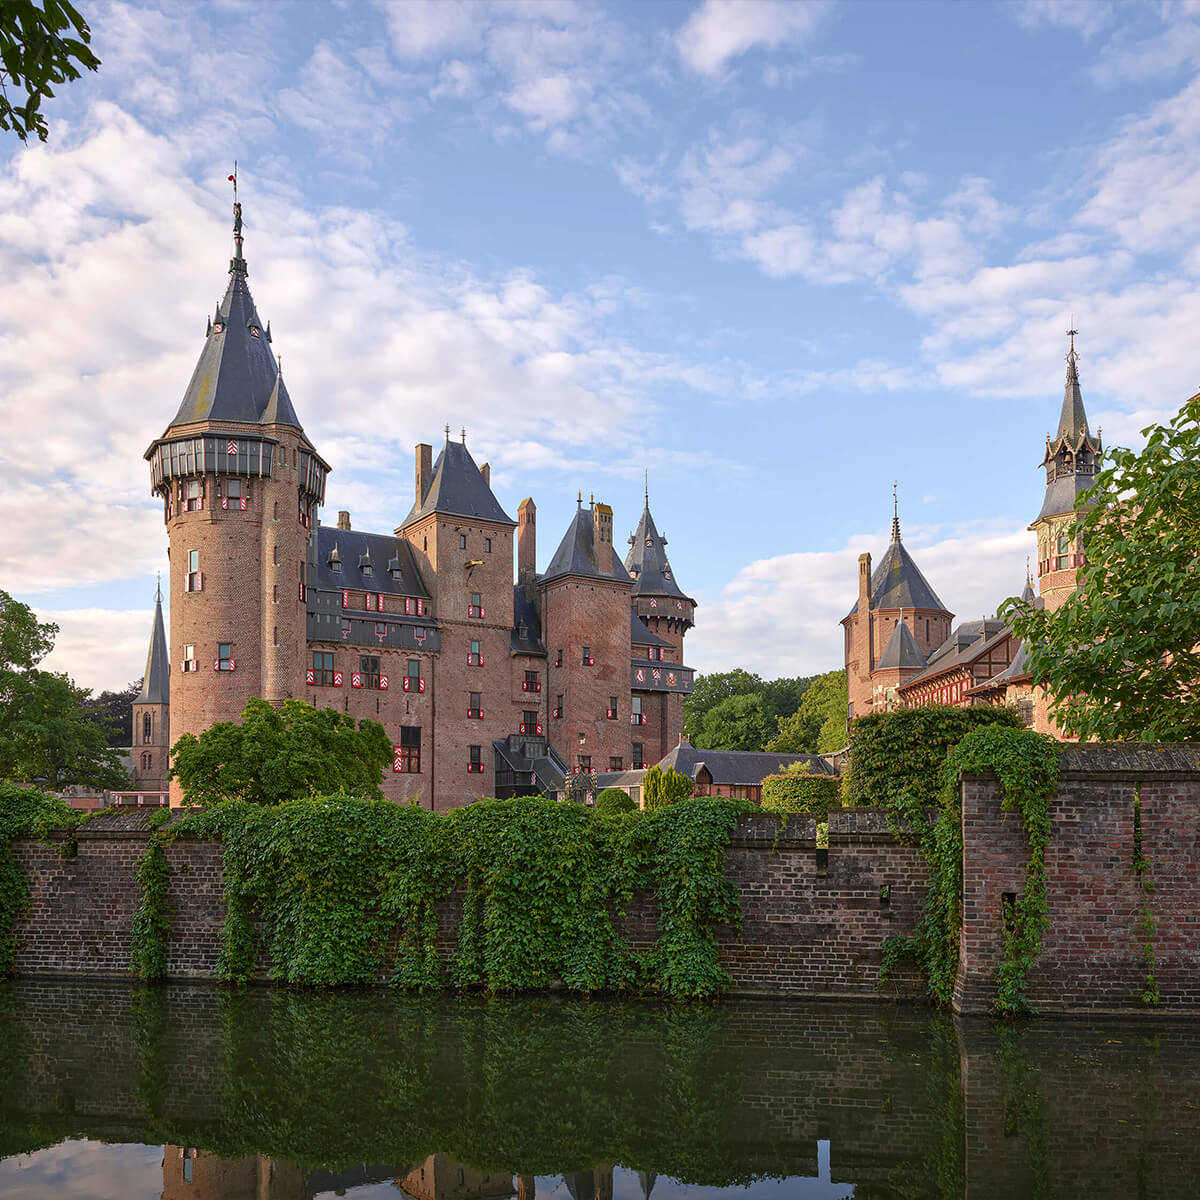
[168,204,301,430]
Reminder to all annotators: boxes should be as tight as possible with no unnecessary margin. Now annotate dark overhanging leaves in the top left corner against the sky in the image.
[0,0,100,142]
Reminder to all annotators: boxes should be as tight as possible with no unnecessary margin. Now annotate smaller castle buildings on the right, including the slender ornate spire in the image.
[841,330,1103,734]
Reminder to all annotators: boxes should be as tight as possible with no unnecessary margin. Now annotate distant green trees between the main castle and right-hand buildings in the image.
[683,667,847,754]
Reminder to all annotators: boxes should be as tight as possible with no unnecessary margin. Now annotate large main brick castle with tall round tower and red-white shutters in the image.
[132,203,696,810]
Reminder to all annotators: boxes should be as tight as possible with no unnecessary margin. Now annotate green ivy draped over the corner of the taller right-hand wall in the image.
[878,714,1058,1015]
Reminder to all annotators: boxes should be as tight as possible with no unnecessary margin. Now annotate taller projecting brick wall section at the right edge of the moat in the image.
[955,745,1200,1013]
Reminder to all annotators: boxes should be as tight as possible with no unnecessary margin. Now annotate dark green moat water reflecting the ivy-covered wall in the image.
[0,982,1200,1200]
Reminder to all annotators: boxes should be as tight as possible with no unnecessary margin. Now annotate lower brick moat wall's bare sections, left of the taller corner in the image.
[14,810,924,997]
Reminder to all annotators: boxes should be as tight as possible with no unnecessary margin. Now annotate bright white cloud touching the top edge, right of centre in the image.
[676,0,830,76]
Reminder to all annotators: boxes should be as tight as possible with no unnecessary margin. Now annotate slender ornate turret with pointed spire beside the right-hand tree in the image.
[1030,329,1104,610]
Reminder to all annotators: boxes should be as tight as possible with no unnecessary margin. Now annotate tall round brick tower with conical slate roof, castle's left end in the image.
[145,203,329,804]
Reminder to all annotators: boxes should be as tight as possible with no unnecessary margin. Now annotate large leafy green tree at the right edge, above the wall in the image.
[1001,398,1200,742]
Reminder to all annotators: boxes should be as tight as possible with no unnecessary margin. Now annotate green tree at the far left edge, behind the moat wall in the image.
[0,592,128,791]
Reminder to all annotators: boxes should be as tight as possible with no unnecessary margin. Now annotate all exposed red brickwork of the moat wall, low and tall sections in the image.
[13,746,1200,1015]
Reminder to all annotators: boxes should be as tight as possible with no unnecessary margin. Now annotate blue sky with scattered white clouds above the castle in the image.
[0,0,1200,688]
